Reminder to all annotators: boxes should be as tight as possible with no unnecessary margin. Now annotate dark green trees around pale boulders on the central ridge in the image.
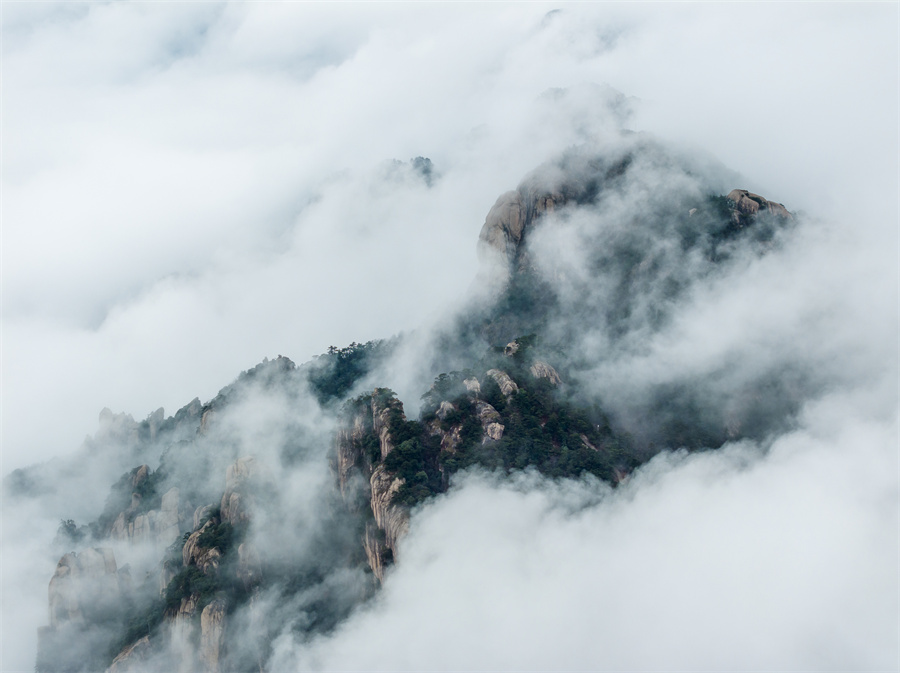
[354,344,639,506]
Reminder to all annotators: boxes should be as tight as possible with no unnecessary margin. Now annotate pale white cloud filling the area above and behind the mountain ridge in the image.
[2,3,897,472]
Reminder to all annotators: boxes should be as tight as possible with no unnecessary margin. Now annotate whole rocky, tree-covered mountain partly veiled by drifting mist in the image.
[17,135,800,672]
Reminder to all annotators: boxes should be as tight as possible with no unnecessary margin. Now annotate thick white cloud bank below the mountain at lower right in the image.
[273,388,900,671]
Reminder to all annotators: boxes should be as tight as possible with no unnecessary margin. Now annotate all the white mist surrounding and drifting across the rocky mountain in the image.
[0,3,900,671]
